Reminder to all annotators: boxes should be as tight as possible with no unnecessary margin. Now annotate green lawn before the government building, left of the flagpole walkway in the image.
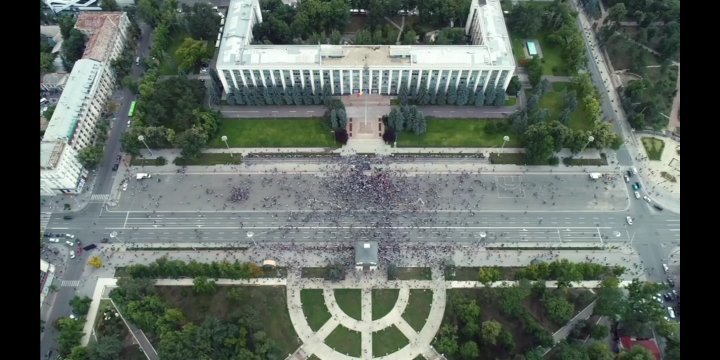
[208,118,340,148]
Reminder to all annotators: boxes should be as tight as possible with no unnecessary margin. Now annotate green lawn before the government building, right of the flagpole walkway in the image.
[398,117,520,147]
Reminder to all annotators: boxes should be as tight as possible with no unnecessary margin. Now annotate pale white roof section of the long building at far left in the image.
[43,59,104,141]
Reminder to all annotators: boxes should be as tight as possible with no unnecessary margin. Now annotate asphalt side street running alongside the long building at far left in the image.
[40,24,151,358]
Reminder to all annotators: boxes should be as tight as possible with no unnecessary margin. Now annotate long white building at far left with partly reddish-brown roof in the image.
[40,12,130,195]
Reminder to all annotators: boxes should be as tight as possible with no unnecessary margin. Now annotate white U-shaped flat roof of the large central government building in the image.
[217,0,515,68]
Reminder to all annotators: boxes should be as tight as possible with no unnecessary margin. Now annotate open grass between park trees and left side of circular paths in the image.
[157,286,300,355]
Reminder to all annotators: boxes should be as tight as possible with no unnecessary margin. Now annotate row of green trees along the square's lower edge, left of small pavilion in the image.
[121,257,263,279]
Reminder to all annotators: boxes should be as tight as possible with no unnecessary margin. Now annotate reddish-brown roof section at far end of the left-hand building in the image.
[75,11,124,61]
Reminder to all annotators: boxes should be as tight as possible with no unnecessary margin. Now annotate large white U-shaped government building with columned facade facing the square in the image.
[216,0,515,95]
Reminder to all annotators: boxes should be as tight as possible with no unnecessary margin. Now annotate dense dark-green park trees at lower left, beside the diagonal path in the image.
[110,277,284,360]
